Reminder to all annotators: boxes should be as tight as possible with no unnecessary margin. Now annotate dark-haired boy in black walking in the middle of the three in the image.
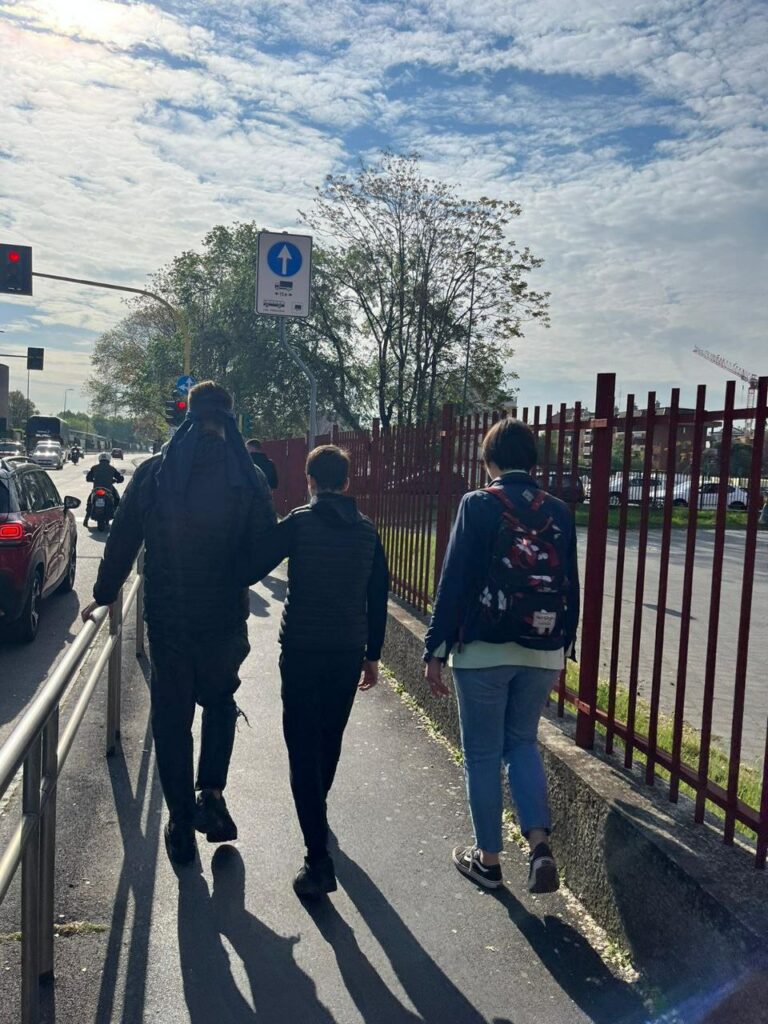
[250,444,389,897]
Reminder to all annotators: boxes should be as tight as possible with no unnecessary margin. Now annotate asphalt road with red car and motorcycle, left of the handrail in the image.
[0,455,143,743]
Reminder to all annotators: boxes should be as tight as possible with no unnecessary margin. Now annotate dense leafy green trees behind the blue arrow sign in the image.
[88,223,370,436]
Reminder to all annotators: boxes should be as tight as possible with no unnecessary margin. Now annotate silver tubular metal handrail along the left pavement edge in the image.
[0,552,144,1024]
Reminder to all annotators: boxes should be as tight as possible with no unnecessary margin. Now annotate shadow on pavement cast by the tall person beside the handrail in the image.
[178,846,334,1024]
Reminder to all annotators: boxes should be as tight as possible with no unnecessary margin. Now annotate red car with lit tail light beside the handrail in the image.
[0,459,80,643]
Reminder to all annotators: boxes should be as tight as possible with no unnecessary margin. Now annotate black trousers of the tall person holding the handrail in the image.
[150,626,251,824]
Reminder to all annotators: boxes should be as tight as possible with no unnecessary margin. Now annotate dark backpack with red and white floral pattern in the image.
[478,486,570,650]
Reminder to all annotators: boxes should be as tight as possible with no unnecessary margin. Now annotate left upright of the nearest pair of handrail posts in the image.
[22,735,42,1024]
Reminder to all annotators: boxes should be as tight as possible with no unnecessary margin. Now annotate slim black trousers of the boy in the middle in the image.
[280,649,364,863]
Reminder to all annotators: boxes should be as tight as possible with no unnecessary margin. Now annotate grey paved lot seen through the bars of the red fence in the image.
[580,530,768,761]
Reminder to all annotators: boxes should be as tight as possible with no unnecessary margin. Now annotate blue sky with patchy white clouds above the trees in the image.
[0,0,768,412]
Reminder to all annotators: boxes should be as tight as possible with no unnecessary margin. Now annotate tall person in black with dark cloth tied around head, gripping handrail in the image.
[83,381,275,864]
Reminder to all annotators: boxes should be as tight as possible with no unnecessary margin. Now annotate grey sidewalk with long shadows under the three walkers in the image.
[0,578,647,1024]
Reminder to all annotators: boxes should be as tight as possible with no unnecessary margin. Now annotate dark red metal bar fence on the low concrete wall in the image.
[264,374,768,867]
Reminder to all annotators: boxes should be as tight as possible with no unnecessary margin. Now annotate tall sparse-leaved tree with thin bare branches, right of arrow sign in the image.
[302,153,549,429]
